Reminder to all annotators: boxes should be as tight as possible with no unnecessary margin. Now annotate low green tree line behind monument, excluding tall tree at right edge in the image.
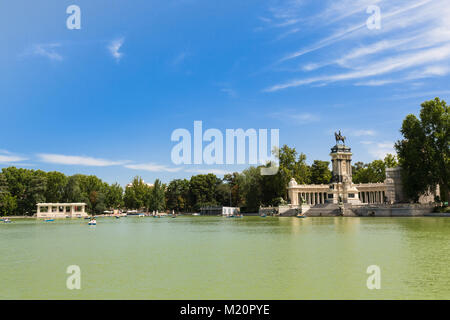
[0,145,398,215]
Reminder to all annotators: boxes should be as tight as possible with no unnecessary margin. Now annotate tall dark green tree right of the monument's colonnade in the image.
[395,98,450,201]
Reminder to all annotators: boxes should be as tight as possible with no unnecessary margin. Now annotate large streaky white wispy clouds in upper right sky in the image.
[264,0,450,92]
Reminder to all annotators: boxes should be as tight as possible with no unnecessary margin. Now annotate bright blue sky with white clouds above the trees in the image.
[0,0,450,184]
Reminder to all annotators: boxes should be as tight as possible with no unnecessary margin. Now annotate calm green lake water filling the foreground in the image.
[0,216,450,299]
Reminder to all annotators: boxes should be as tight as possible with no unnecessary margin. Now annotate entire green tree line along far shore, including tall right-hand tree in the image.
[0,98,450,215]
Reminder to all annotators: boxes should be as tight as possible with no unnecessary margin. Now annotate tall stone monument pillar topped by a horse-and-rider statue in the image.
[328,131,360,204]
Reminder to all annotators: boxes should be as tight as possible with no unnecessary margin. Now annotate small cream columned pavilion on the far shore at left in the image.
[37,202,88,218]
